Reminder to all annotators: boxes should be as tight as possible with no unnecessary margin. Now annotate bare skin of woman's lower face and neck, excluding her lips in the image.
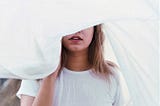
[62,27,93,71]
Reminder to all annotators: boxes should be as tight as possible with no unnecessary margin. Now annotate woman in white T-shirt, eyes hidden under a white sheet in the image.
[17,24,130,106]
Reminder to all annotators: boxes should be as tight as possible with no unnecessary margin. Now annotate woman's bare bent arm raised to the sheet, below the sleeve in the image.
[21,70,58,106]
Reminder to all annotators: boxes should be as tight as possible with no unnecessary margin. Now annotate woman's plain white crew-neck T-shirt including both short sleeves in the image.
[17,68,131,106]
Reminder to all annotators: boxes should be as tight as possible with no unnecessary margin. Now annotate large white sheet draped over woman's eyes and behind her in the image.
[0,0,160,106]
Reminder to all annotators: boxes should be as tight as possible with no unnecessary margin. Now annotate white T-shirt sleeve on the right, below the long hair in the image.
[113,70,132,106]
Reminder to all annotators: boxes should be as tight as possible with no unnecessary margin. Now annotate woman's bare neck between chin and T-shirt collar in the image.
[65,51,90,71]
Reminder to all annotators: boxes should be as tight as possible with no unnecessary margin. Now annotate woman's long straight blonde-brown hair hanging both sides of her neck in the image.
[59,24,116,80]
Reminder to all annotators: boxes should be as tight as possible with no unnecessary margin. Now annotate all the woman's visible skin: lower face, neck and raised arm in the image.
[21,27,94,106]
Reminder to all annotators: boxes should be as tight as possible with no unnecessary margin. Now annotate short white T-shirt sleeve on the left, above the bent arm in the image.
[16,80,40,98]
